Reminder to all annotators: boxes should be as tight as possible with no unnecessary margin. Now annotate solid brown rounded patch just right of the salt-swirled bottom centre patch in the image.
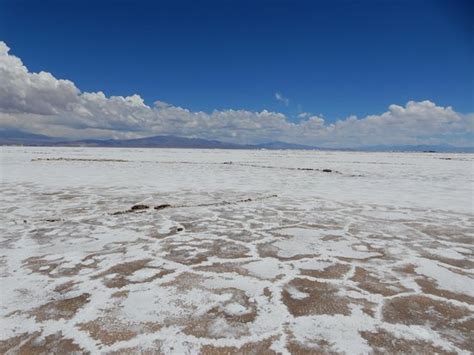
[282,278,351,317]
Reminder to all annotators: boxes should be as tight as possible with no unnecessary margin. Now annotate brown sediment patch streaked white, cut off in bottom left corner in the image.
[0,332,89,355]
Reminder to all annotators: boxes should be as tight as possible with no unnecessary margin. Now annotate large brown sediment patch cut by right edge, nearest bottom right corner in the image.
[382,295,474,352]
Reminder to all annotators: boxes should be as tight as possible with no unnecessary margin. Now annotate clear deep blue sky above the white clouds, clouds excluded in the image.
[0,0,474,122]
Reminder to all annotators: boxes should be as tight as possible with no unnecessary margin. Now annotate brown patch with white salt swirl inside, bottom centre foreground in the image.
[183,288,257,338]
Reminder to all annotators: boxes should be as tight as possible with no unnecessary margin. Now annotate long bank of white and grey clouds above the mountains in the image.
[0,42,474,147]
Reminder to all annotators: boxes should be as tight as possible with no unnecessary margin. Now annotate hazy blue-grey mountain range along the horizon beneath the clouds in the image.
[0,130,474,153]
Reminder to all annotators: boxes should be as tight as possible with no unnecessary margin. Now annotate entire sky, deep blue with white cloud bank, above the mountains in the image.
[0,0,474,147]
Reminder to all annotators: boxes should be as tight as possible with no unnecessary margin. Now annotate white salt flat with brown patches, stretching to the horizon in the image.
[0,147,474,354]
